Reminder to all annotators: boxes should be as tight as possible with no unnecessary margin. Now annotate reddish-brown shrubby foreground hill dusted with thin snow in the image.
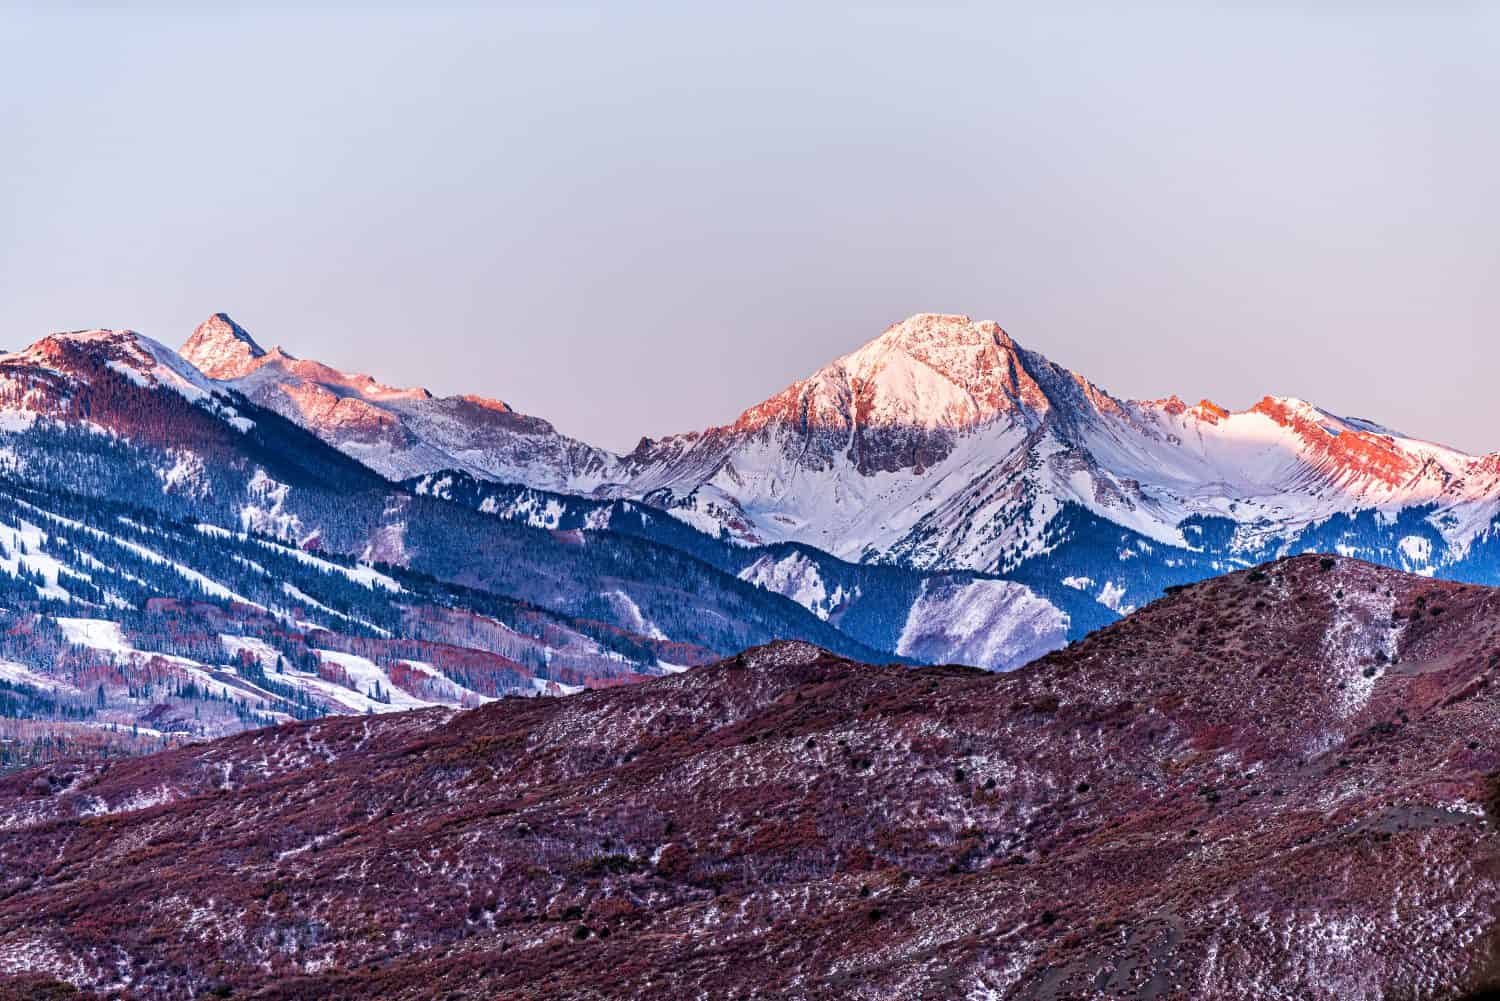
[0,557,1500,999]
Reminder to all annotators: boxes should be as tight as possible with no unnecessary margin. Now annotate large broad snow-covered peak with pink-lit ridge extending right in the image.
[615,314,1500,582]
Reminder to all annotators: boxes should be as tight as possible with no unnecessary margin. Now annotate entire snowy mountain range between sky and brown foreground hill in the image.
[0,314,1500,759]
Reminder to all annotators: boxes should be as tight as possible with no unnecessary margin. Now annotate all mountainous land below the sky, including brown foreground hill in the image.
[0,314,1500,1001]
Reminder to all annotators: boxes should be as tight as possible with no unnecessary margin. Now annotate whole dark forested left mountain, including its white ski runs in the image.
[0,330,948,747]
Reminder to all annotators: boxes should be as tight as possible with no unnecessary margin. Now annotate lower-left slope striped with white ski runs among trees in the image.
[0,479,687,764]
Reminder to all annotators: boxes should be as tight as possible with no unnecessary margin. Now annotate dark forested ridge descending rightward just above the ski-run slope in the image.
[0,325,906,702]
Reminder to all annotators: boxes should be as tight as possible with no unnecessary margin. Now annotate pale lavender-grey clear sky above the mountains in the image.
[0,3,1500,452]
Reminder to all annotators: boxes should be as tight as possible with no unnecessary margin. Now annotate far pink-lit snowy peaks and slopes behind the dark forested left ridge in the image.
[170,314,1500,632]
